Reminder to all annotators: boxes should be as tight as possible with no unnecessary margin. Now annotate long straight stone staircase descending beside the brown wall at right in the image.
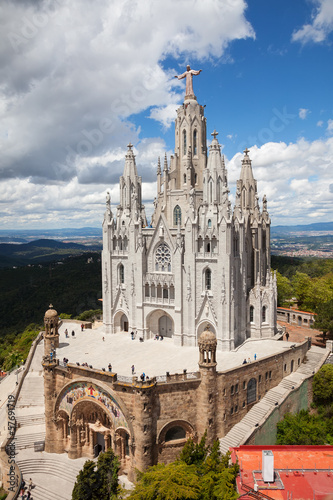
[220,346,327,454]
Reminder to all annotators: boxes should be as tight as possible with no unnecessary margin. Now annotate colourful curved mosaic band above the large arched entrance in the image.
[58,382,128,429]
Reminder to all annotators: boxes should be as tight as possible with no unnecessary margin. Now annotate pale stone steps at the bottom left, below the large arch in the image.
[17,453,84,500]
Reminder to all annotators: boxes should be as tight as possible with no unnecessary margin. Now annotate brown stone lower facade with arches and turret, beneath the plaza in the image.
[43,330,309,480]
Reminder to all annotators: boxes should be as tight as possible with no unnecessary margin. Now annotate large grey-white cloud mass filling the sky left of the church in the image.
[0,0,255,227]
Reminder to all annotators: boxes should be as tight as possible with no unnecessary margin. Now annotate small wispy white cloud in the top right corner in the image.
[291,0,333,44]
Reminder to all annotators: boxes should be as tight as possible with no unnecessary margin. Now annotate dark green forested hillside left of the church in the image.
[0,252,102,337]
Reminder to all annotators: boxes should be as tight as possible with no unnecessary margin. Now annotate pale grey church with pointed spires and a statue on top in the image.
[102,66,277,351]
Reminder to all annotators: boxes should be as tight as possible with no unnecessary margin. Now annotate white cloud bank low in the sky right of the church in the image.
[226,137,333,225]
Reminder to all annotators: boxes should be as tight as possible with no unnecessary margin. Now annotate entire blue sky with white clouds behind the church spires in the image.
[0,0,333,229]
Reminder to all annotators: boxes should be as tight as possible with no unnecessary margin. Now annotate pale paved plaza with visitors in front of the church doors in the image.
[57,321,291,377]
